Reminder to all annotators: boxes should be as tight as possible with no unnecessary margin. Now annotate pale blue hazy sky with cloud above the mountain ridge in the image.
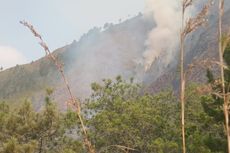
[0,0,145,68]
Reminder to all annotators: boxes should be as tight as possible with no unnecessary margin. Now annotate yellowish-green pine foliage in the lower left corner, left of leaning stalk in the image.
[0,93,84,153]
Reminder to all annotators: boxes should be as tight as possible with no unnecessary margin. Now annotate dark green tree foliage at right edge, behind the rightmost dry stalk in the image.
[201,46,230,153]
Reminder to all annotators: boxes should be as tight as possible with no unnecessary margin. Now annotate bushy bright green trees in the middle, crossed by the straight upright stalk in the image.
[83,77,214,153]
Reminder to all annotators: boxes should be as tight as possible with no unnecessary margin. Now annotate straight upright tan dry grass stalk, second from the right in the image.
[180,8,186,153]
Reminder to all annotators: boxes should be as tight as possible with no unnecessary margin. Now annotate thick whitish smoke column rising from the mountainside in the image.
[143,0,181,70]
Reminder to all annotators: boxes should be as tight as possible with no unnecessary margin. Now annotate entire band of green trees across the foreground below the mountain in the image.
[0,44,230,153]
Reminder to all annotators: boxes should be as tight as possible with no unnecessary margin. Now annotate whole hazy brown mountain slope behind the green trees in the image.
[0,5,230,109]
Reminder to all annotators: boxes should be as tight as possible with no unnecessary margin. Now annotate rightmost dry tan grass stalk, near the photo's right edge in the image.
[218,0,230,153]
